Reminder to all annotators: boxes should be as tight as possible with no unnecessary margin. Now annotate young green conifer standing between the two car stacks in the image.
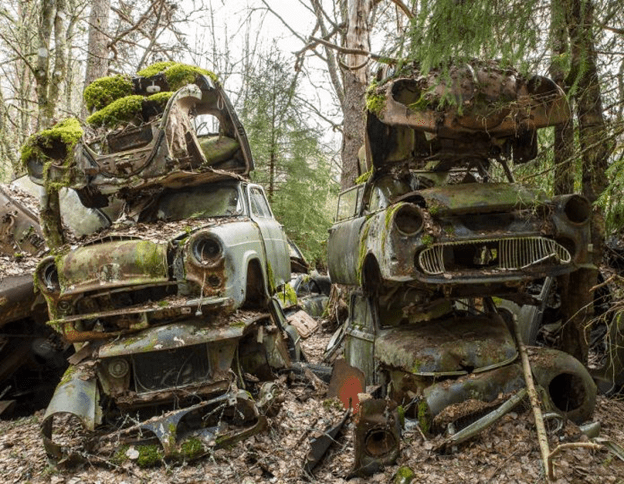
[239,53,338,265]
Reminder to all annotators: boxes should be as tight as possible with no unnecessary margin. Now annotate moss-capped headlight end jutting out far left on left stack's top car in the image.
[20,118,84,166]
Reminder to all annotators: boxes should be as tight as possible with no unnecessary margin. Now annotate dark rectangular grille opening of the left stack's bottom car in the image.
[132,344,210,393]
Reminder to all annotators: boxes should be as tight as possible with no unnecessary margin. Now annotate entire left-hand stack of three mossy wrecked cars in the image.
[24,63,299,459]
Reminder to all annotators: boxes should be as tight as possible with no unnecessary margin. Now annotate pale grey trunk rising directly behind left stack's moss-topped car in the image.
[83,0,110,116]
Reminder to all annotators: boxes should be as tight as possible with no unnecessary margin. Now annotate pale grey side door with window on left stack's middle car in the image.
[247,185,290,285]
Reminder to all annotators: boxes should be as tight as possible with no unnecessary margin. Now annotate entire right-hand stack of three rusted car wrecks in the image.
[328,62,596,472]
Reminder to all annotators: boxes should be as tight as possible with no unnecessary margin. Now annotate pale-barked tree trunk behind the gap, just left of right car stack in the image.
[340,0,371,189]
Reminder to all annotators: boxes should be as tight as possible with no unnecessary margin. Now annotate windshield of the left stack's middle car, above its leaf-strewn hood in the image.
[156,185,243,221]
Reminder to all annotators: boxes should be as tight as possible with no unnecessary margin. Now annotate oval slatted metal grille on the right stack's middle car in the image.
[418,237,572,275]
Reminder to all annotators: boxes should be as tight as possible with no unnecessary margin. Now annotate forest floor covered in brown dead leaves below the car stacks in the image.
[0,326,624,484]
